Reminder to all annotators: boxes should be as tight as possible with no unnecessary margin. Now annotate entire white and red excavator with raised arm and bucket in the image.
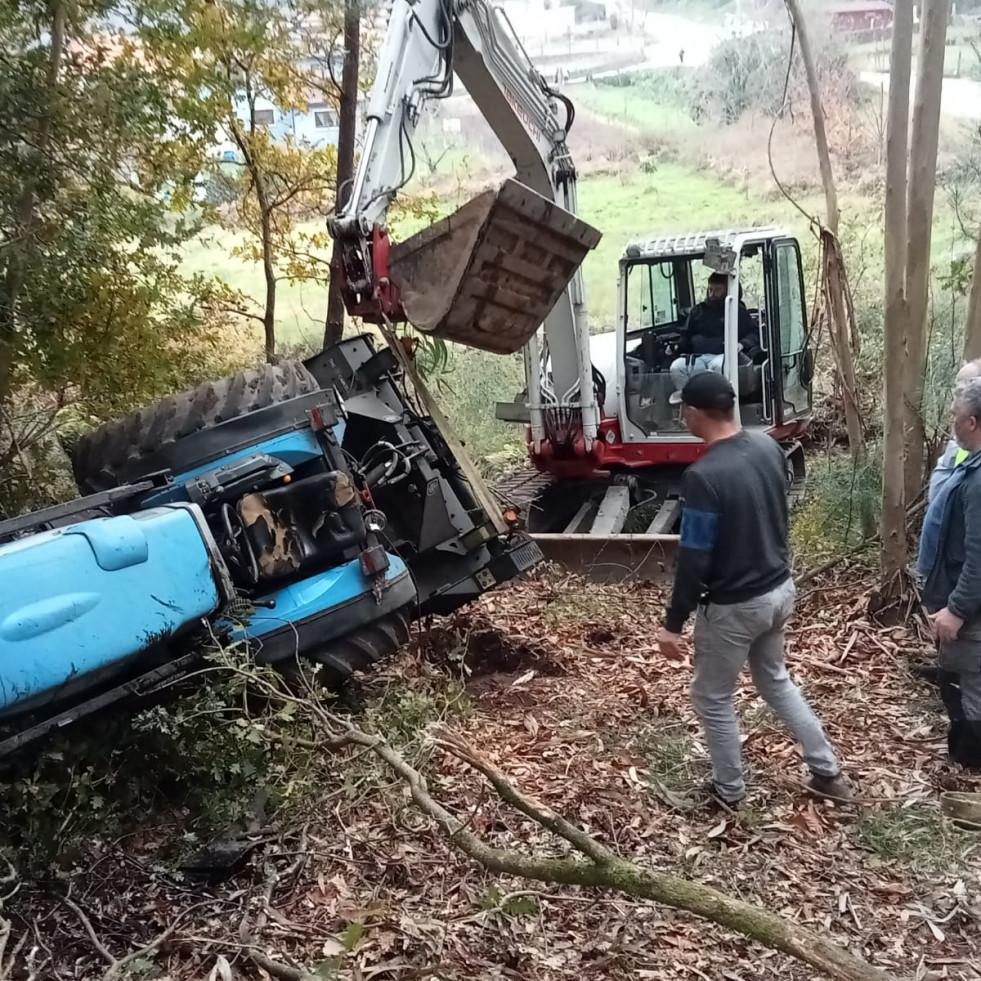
[330,0,810,579]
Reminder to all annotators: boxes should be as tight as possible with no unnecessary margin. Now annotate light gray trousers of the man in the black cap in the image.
[691,579,841,801]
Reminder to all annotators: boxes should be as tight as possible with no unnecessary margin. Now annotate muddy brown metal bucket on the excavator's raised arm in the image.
[388,180,600,354]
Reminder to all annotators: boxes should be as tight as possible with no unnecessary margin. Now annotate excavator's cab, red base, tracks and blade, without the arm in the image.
[498,228,813,580]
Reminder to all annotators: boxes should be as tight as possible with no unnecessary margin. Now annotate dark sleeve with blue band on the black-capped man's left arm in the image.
[664,467,719,634]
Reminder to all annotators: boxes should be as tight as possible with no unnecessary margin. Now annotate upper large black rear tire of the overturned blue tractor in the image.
[71,361,320,494]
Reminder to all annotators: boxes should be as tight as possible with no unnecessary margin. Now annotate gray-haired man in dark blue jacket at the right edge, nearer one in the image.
[917,378,981,767]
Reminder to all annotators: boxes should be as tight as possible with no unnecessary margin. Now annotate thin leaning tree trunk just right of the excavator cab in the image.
[785,0,875,538]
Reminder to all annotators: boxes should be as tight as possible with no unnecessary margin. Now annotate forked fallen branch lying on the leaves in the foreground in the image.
[310,706,894,981]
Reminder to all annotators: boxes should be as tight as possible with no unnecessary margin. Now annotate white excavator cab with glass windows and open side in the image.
[604,228,813,444]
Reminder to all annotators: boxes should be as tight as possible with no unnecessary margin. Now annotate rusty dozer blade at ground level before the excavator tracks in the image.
[531,533,678,583]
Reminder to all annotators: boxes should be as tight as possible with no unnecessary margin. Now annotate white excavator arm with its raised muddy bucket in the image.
[330,0,602,450]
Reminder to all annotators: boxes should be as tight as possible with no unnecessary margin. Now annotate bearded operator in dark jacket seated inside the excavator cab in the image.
[668,273,763,405]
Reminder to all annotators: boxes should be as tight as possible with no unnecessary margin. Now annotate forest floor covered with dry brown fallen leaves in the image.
[7,570,981,981]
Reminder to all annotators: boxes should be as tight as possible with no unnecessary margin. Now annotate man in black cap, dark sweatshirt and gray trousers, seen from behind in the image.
[658,371,851,804]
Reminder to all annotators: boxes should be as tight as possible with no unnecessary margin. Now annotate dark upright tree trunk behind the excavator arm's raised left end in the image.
[324,0,361,348]
